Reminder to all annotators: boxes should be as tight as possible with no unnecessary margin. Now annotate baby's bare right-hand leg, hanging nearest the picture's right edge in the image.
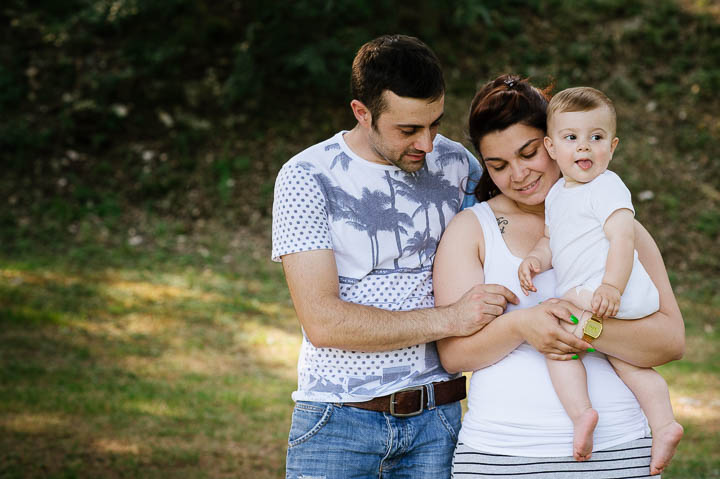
[608,356,683,474]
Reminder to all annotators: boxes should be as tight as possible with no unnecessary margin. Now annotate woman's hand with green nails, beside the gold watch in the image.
[516,299,591,361]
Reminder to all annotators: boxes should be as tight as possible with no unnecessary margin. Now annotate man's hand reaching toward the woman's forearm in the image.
[449,284,519,336]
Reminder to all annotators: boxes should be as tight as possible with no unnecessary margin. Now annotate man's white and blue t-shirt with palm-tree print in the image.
[272,132,480,402]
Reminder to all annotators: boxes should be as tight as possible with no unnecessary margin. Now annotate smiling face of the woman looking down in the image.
[480,123,560,206]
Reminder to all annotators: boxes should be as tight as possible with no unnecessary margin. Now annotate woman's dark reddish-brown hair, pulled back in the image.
[468,75,552,201]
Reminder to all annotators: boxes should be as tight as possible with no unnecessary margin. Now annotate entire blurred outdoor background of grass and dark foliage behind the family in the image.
[0,0,720,477]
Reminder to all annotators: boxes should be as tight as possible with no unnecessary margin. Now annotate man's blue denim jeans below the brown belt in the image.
[285,401,462,479]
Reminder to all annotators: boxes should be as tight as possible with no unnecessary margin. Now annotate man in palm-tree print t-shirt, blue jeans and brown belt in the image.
[272,35,517,478]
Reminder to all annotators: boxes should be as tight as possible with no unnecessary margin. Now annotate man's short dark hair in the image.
[350,35,445,122]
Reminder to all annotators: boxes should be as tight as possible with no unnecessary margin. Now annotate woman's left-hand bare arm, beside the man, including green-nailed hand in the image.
[433,210,589,372]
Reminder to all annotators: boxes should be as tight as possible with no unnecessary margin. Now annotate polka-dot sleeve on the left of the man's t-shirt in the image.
[272,164,332,261]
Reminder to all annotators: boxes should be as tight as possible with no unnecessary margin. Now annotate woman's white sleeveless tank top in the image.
[459,202,650,457]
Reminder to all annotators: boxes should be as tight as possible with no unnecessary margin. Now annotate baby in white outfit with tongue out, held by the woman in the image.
[518,87,683,474]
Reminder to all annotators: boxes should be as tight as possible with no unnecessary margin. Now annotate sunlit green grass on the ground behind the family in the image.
[0,220,720,479]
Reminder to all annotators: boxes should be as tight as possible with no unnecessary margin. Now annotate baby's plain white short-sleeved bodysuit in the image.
[545,170,660,319]
